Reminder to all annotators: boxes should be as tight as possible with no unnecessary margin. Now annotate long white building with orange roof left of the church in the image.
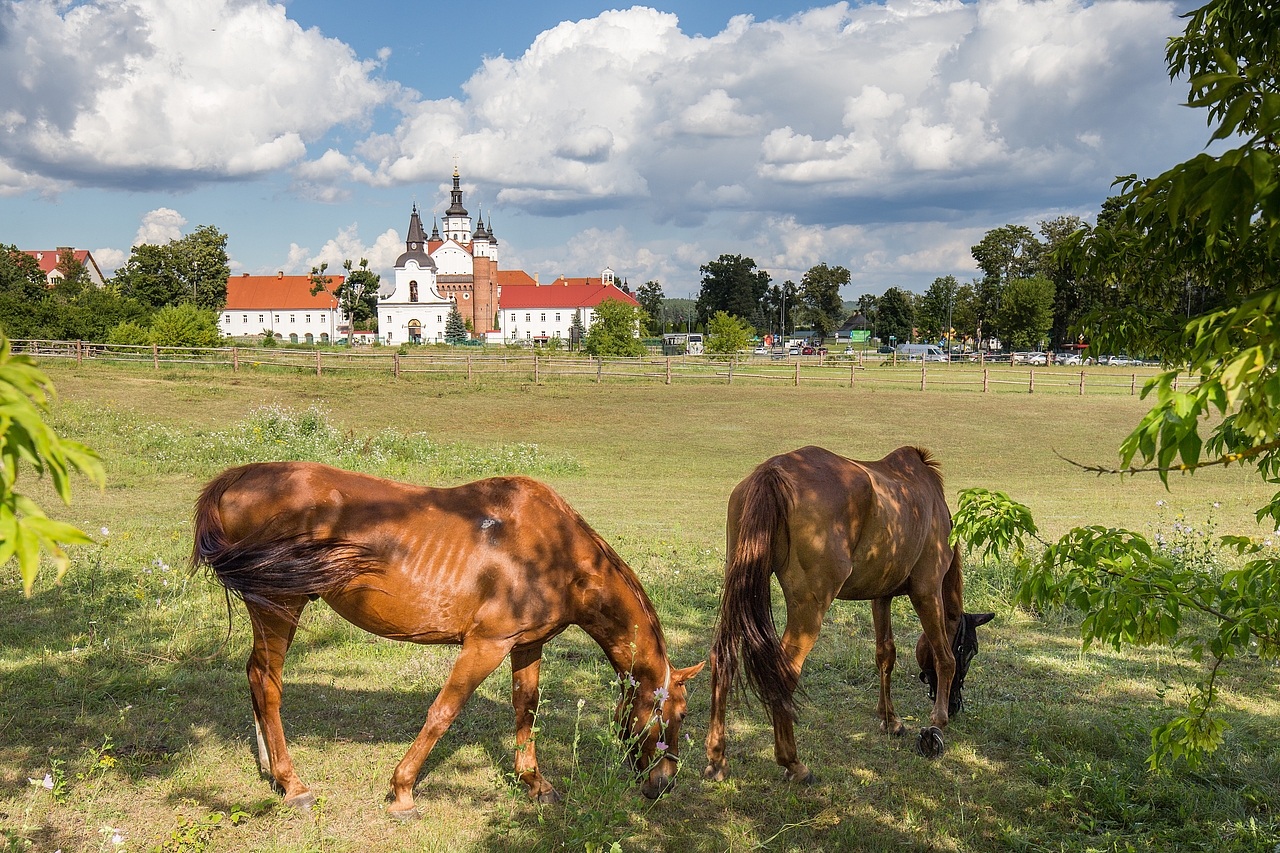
[219,272,351,343]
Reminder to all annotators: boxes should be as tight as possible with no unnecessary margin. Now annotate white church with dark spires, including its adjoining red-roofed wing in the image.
[378,168,635,346]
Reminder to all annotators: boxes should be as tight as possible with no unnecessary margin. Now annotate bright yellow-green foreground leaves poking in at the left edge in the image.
[0,333,106,596]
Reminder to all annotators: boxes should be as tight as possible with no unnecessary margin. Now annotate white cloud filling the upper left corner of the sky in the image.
[0,0,397,192]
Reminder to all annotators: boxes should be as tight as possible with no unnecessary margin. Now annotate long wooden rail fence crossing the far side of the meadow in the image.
[13,339,1192,396]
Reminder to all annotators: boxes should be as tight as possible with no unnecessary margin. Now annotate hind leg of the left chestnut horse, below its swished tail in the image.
[246,598,315,808]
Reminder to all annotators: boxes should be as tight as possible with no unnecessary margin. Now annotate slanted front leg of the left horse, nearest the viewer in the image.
[387,637,511,820]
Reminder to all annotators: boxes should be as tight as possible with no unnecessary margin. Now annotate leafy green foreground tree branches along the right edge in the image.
[955,0,1280,766]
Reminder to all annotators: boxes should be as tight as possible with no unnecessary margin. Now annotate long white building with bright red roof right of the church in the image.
[498,268,640,343]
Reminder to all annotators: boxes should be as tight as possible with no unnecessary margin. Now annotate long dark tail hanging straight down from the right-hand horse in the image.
[710,464,800,720]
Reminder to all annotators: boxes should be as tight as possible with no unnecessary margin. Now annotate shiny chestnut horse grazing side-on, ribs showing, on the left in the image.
[192,462,703,817]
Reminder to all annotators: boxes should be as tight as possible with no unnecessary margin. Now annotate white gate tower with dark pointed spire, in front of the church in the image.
[378,205,455,346]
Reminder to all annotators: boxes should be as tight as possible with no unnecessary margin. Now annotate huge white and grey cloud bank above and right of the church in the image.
[307,0,1203,224]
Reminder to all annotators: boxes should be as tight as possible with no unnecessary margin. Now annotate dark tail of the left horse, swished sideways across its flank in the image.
[191,466,383,619]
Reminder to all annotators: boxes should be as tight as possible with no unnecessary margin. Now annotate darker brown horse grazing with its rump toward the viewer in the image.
[703,447,992,783]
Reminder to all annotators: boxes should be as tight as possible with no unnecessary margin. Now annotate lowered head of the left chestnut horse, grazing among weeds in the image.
[614,661,707,799]
